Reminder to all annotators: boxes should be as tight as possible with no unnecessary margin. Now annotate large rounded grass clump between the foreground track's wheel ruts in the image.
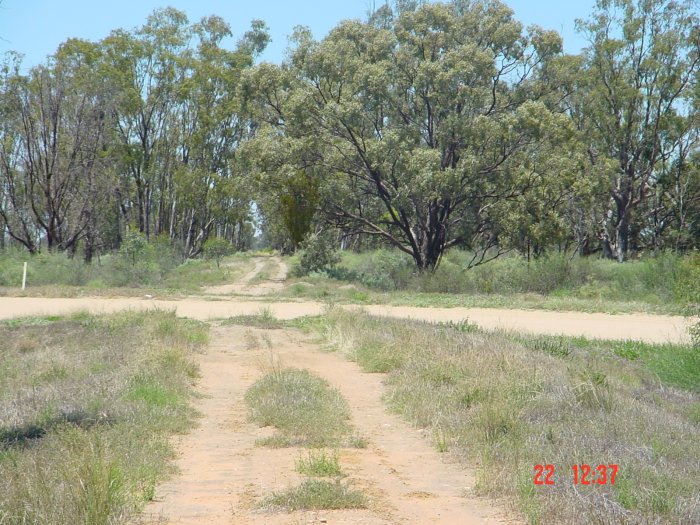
[245,368,353,447]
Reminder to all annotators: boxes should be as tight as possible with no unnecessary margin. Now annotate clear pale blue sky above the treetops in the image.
[0,0,594,66]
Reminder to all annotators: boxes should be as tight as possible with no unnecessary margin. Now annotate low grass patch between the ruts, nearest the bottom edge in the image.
[260,479,367,511]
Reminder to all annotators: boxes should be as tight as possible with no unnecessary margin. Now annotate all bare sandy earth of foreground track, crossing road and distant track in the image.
[0,258,687,525]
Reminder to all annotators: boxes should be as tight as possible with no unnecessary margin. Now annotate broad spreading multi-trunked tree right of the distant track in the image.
[246,0,571,271]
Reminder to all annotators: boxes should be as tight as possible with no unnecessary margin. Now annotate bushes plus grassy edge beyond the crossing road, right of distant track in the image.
[284,250,700,314]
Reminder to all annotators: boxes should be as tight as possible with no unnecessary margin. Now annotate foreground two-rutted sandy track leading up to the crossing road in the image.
[135,327,514,525]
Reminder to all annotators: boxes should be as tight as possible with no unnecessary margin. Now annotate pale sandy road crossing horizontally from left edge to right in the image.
[0,297,688,343]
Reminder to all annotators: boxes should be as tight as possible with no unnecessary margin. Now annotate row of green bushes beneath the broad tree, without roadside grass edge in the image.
[332,249,688,304]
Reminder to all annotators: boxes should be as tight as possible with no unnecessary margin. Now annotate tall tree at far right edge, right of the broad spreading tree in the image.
[578,0,700,261]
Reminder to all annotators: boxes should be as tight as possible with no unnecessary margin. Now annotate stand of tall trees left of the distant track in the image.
[0,9,268,260]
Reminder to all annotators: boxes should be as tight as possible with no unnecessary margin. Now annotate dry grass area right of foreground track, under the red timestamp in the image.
[322,310,700,524]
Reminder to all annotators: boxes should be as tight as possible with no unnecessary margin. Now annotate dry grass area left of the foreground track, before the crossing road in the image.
[0,312,207,525]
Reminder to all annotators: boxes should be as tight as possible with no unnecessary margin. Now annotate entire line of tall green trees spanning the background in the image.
[0,0,700,270]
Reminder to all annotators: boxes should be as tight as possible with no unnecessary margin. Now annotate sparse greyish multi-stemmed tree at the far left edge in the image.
[0,40,110,259]
